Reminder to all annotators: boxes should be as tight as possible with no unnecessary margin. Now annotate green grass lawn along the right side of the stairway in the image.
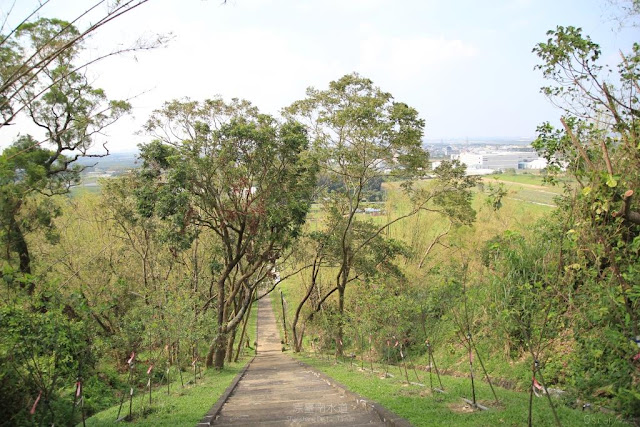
[296,356,626,426]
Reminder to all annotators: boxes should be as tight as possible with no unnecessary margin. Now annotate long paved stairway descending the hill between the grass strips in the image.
[213,298,385,426]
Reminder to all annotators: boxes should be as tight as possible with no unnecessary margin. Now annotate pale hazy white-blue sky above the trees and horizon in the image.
[0,0,640,151]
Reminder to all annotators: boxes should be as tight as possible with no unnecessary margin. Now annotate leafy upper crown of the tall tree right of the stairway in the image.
[284,73,428,187]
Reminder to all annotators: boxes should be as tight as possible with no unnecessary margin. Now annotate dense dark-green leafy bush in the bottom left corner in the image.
[0,293,93,425]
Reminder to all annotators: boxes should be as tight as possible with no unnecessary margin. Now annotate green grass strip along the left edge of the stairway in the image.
[86,303,258,427]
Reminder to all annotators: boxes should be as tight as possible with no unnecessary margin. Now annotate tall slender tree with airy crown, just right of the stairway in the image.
[285,74,475,354]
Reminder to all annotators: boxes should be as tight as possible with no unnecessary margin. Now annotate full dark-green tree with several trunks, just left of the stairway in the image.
[139,99,316,368]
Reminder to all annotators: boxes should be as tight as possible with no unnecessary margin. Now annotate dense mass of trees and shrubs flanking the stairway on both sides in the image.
[0,2,640,425]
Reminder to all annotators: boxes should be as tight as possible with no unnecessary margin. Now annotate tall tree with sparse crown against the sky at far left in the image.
[0,18,130,282]
